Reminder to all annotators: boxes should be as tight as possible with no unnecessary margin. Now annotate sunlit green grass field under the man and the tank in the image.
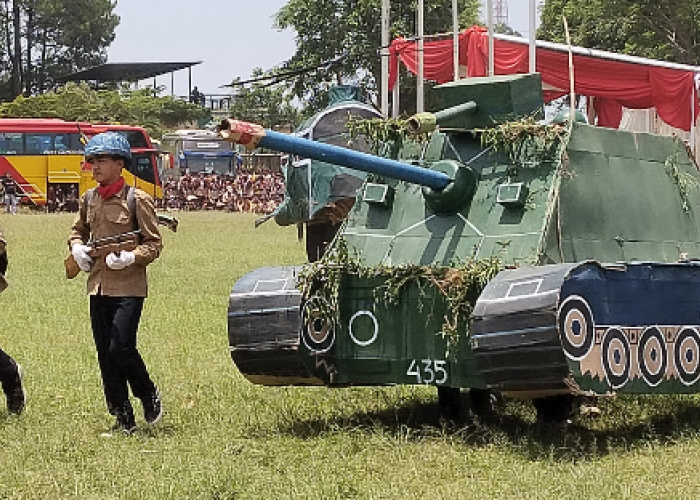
[0,213,700,500]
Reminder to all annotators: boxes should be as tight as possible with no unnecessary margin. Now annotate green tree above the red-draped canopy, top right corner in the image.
[538,0,700,65]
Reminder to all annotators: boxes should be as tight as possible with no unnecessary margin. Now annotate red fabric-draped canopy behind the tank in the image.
[389,26,700,131]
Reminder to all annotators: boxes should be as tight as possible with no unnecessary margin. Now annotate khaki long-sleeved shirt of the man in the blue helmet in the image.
[68,185,163,297]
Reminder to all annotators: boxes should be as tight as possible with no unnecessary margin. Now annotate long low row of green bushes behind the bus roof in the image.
[0,83,208,138]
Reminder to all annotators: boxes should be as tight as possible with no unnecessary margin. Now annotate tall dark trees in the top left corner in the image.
[0,0,119,100]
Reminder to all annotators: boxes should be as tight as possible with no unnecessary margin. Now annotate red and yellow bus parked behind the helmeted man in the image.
[0,118,163,205]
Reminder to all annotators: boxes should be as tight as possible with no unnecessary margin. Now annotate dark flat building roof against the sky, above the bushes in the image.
[56,61,202,82]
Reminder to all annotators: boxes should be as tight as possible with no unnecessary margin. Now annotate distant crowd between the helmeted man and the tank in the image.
[158,169,284,214]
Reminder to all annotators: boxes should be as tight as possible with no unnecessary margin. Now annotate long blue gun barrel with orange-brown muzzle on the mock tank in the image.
[219,119,452,191]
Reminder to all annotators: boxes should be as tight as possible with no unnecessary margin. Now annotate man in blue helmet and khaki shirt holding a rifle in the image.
[68,132,163,433]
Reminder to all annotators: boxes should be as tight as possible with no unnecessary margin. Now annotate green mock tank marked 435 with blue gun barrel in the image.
[221,75,700,416]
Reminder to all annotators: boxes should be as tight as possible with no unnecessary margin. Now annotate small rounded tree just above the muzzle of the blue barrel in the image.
[229,68,300,129]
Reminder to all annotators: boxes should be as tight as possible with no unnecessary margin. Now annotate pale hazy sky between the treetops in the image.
[107,0,530,96]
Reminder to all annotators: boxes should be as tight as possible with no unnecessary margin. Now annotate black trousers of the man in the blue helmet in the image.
[90,295,155,414]
